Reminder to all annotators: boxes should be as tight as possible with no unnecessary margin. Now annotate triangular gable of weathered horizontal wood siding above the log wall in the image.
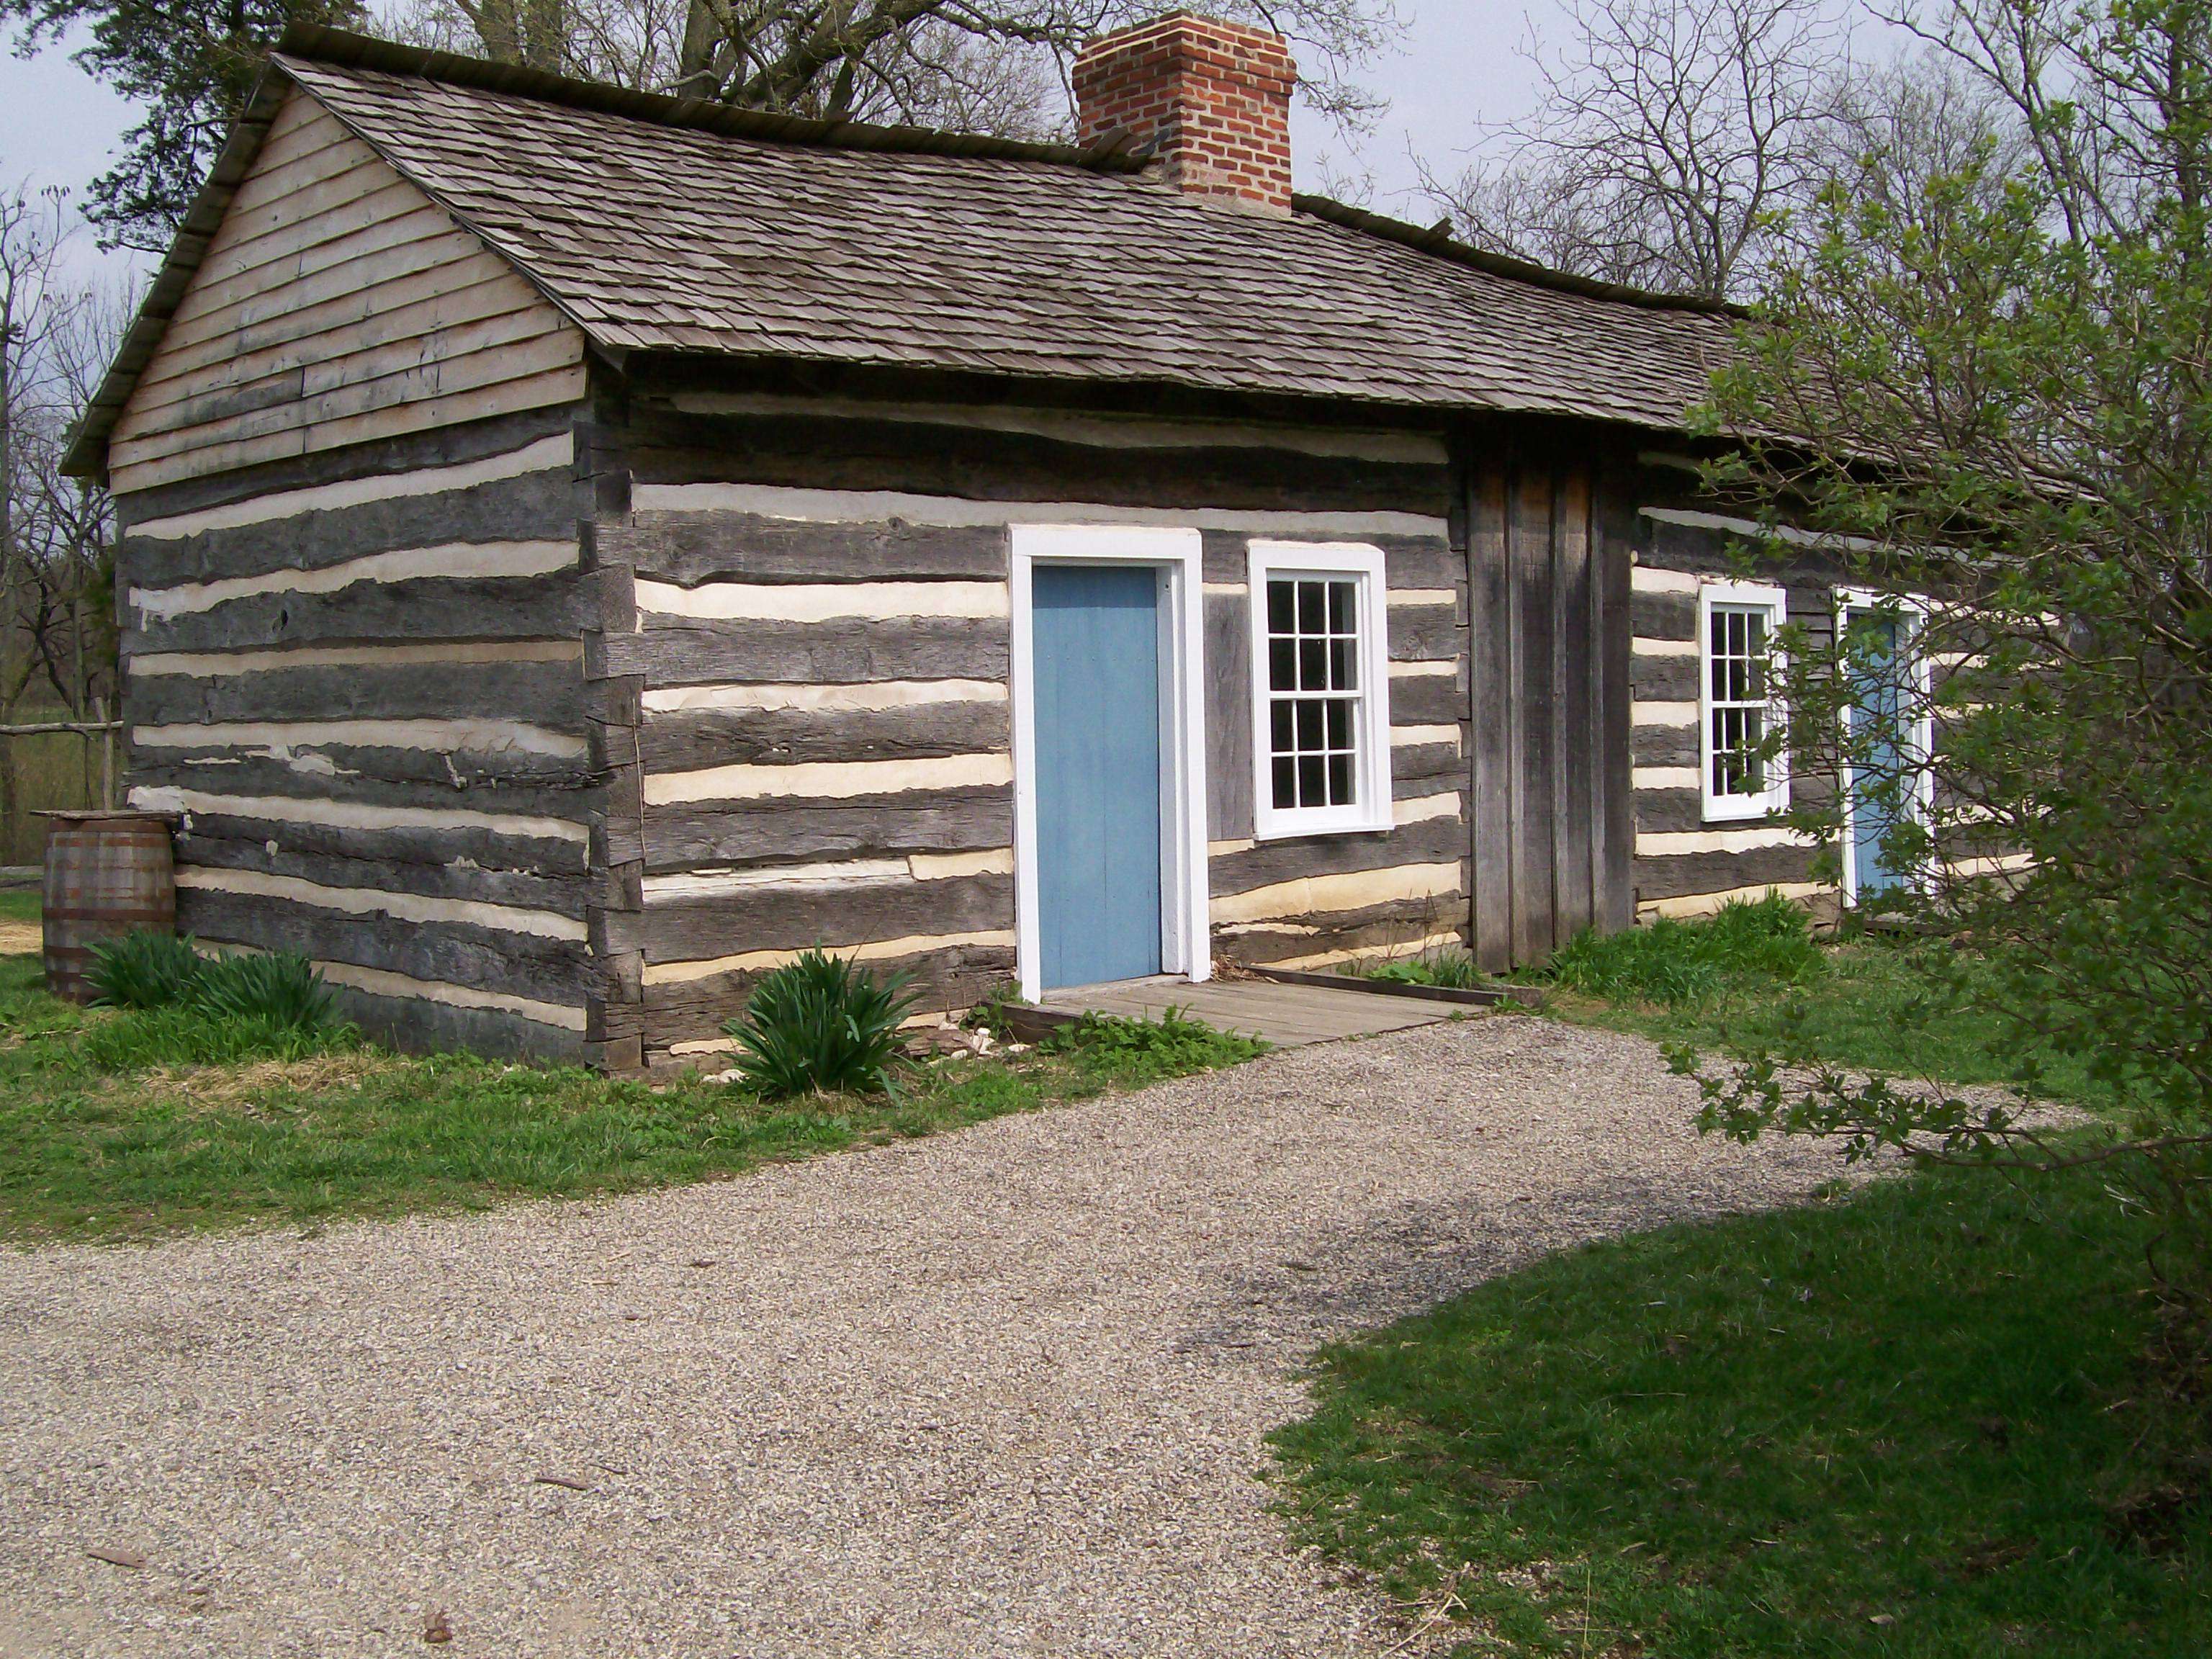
[109,93,584,495]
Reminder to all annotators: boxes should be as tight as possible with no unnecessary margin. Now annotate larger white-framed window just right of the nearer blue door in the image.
[1250,542,1391,840]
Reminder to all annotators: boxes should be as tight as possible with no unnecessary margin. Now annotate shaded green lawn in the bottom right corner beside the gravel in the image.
[1277,1174,2212,1659]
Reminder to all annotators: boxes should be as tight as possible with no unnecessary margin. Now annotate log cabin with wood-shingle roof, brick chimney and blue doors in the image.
[73,18,1902,1069]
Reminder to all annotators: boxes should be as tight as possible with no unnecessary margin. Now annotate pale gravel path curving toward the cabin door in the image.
[0,1017,1834,1659]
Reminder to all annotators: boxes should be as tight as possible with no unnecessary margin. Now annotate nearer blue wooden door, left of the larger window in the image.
[1028,564,1159,986]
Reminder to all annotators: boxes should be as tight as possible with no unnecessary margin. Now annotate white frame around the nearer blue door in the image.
[1011,524,1215,1002]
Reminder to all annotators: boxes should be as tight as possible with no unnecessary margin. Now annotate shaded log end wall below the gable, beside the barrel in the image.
[117,411,606,1057]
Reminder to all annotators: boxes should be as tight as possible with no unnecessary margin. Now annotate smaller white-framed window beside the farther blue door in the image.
[1696,582,1789,823]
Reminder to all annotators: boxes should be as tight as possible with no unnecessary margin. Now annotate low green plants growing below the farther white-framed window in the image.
[1544,894,1825,1007]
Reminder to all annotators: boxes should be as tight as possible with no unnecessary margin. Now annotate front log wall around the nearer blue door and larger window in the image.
[590,382,1467,1062]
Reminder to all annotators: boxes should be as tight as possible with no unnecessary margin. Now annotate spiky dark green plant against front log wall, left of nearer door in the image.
[724,951,914,1100]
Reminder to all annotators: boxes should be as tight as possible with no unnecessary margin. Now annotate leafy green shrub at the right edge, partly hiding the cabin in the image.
[1706,0,2212,1370]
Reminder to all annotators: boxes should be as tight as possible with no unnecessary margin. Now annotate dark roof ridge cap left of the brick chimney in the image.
[274,22,1150,173]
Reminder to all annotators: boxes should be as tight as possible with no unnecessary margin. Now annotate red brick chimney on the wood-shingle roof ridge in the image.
[1075,11,1298,212]
